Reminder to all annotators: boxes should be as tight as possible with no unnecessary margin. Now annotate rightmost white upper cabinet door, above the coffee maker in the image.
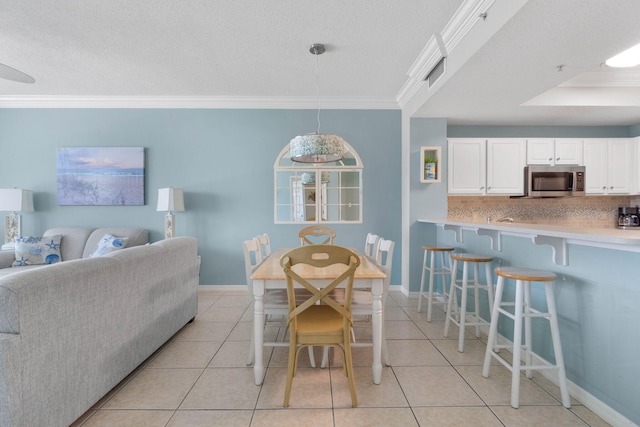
[607,138,634,194]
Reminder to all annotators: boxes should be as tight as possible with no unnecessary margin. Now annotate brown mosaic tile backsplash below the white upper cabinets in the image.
[448,195,640,228]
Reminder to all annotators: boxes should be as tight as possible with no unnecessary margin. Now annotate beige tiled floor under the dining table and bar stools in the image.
[74,291,608,427]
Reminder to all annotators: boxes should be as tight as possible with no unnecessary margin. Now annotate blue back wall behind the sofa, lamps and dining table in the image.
[0,109,401,285]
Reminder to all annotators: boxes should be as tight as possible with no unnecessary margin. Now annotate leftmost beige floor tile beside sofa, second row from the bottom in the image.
[102,369,203,409]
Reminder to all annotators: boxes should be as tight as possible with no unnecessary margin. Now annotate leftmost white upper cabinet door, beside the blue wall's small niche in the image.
[447,138,486,194]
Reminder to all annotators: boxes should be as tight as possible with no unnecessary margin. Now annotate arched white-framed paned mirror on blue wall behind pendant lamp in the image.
[273,144,363,224]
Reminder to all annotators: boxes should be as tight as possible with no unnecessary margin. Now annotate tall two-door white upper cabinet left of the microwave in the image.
[448,138,526,195]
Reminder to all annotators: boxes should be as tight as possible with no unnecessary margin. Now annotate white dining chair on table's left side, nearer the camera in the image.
[242,237,316,368]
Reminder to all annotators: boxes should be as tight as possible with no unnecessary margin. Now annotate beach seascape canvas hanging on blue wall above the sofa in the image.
[56,147,144,206]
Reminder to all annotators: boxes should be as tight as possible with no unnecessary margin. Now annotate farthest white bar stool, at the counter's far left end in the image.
[418,246,454,322]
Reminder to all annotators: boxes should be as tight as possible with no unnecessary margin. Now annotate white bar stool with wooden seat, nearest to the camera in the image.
[482,267,571,408]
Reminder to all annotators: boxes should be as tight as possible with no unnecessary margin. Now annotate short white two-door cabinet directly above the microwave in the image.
[527,138,583,166]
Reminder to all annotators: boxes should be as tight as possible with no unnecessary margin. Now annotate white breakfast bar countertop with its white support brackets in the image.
[418,218,640,265]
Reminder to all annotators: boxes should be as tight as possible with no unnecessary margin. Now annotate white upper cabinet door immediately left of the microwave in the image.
[487,138,527,196]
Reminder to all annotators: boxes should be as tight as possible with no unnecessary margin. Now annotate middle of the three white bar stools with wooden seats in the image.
[444,253,493,353]
